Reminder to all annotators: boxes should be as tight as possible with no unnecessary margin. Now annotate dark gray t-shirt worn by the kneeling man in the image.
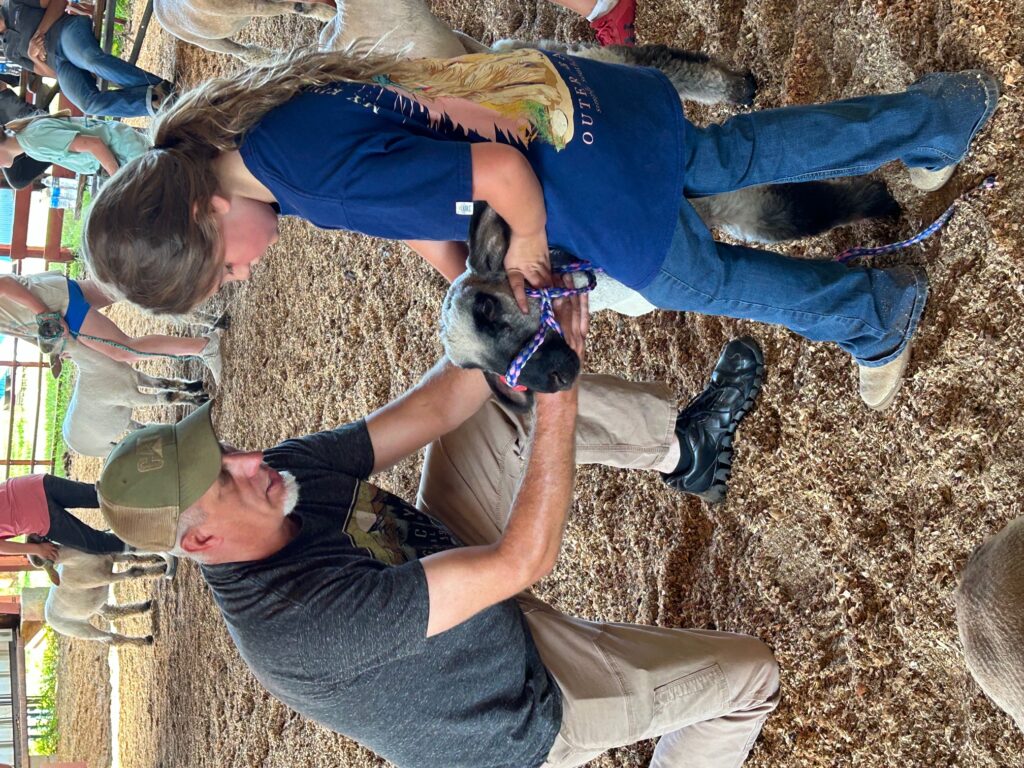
[203,422,561,768]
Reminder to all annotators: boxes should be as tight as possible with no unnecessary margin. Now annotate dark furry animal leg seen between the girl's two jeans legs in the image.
[690,176,900,243]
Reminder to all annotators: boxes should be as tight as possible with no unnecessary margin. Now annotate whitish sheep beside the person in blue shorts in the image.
[63,341,209,458]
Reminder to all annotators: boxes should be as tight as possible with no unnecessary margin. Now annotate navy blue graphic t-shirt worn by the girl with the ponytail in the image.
[241,49,684,287]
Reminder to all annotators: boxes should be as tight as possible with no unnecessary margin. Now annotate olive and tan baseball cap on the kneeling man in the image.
[96,402,221,552]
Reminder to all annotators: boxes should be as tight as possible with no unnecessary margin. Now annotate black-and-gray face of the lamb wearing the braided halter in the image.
[441,204,580,392]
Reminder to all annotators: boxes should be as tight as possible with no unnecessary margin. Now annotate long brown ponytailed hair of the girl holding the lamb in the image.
[83,46,408,313]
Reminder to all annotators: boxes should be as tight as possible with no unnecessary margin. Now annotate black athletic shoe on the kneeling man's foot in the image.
[662,336,765,504]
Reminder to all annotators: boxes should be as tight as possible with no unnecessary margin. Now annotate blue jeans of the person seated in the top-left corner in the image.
[49,16,165,118]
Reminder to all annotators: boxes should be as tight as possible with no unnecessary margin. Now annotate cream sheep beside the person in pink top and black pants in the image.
[29,547,167,645]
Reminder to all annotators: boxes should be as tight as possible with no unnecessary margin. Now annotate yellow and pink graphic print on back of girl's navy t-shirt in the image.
[311,49,599,151]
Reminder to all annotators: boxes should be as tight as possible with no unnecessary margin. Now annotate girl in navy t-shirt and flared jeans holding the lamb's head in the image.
[85,50,998,407]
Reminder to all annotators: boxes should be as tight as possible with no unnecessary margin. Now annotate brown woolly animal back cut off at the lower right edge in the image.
[955,517,1024,731]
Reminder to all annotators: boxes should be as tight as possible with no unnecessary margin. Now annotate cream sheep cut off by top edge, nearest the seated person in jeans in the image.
[153,0,335,63]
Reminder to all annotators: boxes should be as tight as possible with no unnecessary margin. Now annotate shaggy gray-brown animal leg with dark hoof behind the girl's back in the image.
[572,45,757,106]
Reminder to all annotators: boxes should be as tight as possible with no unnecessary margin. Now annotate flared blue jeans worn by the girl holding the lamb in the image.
[639,72,998,367]
